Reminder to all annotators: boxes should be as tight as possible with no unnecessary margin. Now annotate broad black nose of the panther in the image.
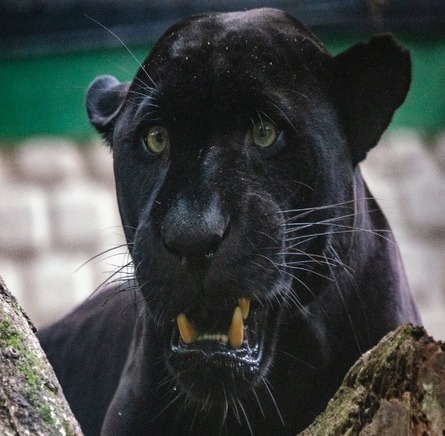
[161,198,228,269]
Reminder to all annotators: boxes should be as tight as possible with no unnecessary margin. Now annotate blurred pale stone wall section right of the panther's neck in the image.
[362,130,445,339]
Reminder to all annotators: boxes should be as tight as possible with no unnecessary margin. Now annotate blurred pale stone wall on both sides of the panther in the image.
[0,131,445,339]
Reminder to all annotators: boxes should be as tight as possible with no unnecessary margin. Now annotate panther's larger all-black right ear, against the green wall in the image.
[333,34,411,165]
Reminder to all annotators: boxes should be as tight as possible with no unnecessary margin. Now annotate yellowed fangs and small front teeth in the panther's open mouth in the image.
[176,298,250,349]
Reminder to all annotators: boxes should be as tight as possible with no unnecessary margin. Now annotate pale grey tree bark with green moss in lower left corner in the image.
[0,277,82,436]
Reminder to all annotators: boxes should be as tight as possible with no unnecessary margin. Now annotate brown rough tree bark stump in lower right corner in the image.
[300,325,445,436]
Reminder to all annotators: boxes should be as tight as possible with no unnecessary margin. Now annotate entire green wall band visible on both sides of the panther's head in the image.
[0,37,445,141]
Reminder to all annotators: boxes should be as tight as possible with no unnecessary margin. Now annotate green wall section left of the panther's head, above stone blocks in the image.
[0,48,153,139]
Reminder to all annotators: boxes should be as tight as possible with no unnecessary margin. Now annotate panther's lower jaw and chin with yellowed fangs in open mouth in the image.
[167,298,273,405]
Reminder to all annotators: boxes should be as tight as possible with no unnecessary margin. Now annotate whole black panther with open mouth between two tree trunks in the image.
[40,9,421,436]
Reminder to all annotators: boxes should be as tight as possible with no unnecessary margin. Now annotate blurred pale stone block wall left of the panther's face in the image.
[0,138,125,326]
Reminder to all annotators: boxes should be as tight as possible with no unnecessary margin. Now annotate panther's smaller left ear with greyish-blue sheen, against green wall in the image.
[87,76,130,140]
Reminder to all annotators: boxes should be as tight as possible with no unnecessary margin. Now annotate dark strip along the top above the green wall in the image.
[0,0,445,55]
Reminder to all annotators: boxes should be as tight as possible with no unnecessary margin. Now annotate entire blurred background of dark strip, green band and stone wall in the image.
[0,0,445,339]
